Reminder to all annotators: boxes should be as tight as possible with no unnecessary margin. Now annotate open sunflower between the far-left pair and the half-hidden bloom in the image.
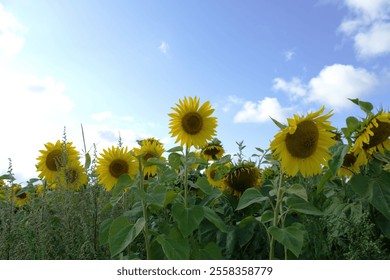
[96,146,138,191]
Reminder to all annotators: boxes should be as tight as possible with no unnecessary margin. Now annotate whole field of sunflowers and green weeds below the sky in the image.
[0,97,390,260]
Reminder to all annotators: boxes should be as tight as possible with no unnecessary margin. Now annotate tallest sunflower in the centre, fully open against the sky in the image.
[168,97,217,148]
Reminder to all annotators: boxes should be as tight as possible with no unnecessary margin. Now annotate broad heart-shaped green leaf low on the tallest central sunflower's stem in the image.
[172,203,204,237]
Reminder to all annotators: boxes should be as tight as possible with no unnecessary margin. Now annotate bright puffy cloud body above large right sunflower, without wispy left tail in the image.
[308,64,378,108]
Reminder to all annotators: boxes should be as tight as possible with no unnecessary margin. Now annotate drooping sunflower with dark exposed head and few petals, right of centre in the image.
[223,162,262,196]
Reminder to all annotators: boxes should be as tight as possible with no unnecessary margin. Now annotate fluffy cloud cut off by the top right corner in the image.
[339,0,390,59]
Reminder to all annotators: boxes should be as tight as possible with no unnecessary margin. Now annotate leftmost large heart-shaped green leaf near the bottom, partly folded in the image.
[108,216,145,257]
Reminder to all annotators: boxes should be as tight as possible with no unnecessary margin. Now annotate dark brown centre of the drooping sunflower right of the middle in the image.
[226,167,259,193]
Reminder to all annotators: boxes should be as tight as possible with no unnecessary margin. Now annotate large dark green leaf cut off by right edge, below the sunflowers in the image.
[350,172,390,220]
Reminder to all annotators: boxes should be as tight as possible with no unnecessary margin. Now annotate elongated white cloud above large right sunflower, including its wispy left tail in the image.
[273,64,378,109]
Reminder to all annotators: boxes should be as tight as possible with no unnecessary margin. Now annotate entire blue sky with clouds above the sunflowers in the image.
[0,0,390,182]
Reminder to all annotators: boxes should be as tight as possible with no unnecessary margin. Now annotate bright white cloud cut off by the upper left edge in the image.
[0,3,26,57]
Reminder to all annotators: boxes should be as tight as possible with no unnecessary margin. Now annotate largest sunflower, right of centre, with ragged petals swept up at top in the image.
[270,107,335,177]
